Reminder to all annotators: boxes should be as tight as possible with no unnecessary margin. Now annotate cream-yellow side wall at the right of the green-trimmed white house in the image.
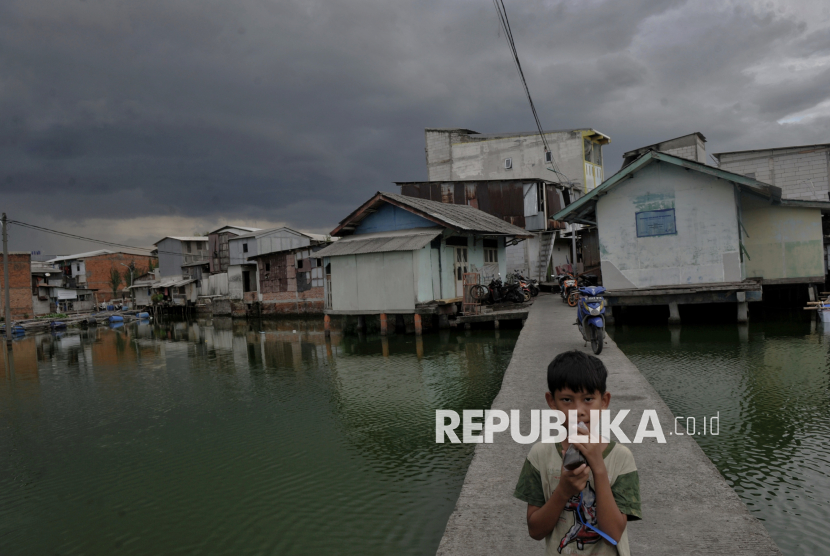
[741,194,824,280]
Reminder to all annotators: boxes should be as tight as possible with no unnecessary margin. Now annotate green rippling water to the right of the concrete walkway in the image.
[612,314,830,556]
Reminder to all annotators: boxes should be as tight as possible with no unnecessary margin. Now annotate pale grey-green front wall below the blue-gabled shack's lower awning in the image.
[330,251,417,311]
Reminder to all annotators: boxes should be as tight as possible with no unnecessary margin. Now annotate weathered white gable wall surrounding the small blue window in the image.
[597,163,741,290]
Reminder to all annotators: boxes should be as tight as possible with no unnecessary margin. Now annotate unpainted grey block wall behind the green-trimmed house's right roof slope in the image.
[719,146,830,201]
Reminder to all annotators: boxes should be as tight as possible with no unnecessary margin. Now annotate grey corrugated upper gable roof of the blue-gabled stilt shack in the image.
[331,191,533,237]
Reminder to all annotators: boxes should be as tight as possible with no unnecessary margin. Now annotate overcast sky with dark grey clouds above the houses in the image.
[0,0,830,254]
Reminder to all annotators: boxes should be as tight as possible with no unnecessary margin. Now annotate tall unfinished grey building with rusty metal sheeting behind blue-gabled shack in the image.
[412,128,611,281]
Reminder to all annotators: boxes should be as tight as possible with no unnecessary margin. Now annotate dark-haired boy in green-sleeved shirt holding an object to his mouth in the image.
[513,350,642,556]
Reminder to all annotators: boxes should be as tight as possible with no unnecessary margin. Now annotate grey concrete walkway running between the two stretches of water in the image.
[438,295,781,556]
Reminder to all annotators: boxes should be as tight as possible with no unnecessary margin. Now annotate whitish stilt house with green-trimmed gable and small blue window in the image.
[554,151,830,322]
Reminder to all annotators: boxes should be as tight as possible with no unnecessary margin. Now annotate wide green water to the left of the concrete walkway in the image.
[0,319,518,556]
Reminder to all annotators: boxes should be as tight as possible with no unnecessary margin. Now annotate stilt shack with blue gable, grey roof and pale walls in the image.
[316,192,532,330]
